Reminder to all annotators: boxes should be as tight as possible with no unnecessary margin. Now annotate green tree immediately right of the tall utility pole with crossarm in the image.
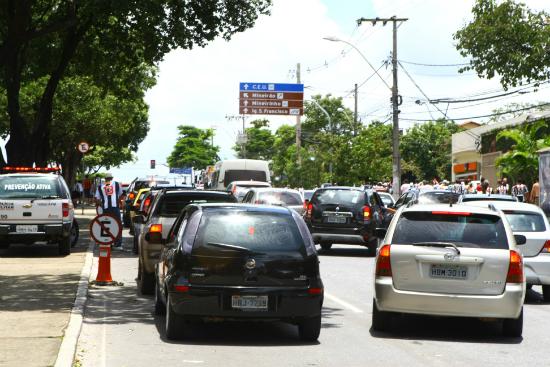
[401,120,460,180]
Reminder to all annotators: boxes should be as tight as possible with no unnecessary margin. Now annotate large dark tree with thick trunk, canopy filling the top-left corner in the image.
[0,0,271,165]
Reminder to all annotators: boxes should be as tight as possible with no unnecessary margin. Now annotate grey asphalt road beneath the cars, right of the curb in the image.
[77,234,550,367]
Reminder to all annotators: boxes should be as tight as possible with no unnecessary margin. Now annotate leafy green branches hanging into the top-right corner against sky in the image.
[454,0,550,89]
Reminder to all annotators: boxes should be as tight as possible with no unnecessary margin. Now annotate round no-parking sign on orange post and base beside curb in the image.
[90,214,122,285]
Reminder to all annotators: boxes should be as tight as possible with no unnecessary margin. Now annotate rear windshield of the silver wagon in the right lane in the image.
[391,211,508,249]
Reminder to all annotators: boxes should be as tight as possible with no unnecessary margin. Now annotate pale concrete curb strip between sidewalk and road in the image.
[55,242,95,367]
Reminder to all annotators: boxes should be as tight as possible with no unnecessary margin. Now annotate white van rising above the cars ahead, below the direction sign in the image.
[209,159,271,190]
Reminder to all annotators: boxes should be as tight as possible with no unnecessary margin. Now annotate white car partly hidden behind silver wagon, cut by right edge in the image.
[466,201,550,302]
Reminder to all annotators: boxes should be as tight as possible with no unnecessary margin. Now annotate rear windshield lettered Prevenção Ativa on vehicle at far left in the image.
[0,175,65,199]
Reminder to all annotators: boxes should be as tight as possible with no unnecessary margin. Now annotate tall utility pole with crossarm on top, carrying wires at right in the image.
[357,15,408,199]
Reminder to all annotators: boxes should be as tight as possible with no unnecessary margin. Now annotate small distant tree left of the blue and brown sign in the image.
[167,125,219,169]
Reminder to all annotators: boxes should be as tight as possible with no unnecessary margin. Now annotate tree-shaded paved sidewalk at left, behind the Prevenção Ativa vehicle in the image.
[0,213,95,367]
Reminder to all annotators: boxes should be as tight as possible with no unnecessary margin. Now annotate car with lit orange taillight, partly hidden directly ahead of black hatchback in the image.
[134,188,237,294]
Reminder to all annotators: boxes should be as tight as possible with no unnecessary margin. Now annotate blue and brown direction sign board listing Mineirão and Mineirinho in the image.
[239,83,304,116]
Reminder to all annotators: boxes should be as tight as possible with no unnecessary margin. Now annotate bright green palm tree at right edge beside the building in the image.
[496,120,550,187]
